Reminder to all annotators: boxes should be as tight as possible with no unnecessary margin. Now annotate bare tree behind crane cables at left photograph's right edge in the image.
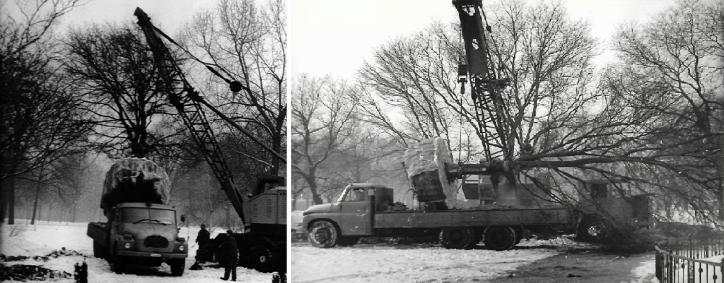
[182,0,287,175]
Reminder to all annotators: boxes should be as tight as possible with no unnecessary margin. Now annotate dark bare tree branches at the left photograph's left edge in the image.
[0,1,88,224]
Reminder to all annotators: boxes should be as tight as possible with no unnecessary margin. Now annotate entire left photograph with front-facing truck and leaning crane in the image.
[0,0,288,282]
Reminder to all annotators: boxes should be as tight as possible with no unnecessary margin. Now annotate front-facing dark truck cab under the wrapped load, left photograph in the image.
[87,202,188,276]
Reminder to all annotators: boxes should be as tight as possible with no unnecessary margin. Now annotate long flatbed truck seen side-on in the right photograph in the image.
[303,183,648,251]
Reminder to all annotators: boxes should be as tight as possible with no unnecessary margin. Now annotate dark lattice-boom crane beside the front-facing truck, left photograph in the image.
[134,8,287,274]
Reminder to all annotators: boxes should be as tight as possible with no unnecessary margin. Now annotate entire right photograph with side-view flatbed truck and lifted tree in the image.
[289,0,724,282]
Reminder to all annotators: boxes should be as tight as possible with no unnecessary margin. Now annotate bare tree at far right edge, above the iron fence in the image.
[605,0,724,222]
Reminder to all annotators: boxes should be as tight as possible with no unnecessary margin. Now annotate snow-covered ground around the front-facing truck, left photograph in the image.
[0,220,272,283]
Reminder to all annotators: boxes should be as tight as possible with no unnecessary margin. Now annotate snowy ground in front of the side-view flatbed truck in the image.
[290,245,557,283]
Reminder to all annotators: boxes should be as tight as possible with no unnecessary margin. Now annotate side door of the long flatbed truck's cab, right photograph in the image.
[339,188,370,236]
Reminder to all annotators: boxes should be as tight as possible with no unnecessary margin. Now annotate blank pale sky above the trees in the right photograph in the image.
[289,0,676,78]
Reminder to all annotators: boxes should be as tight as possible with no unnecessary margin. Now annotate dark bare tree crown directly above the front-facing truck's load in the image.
[66,25,181,157]
